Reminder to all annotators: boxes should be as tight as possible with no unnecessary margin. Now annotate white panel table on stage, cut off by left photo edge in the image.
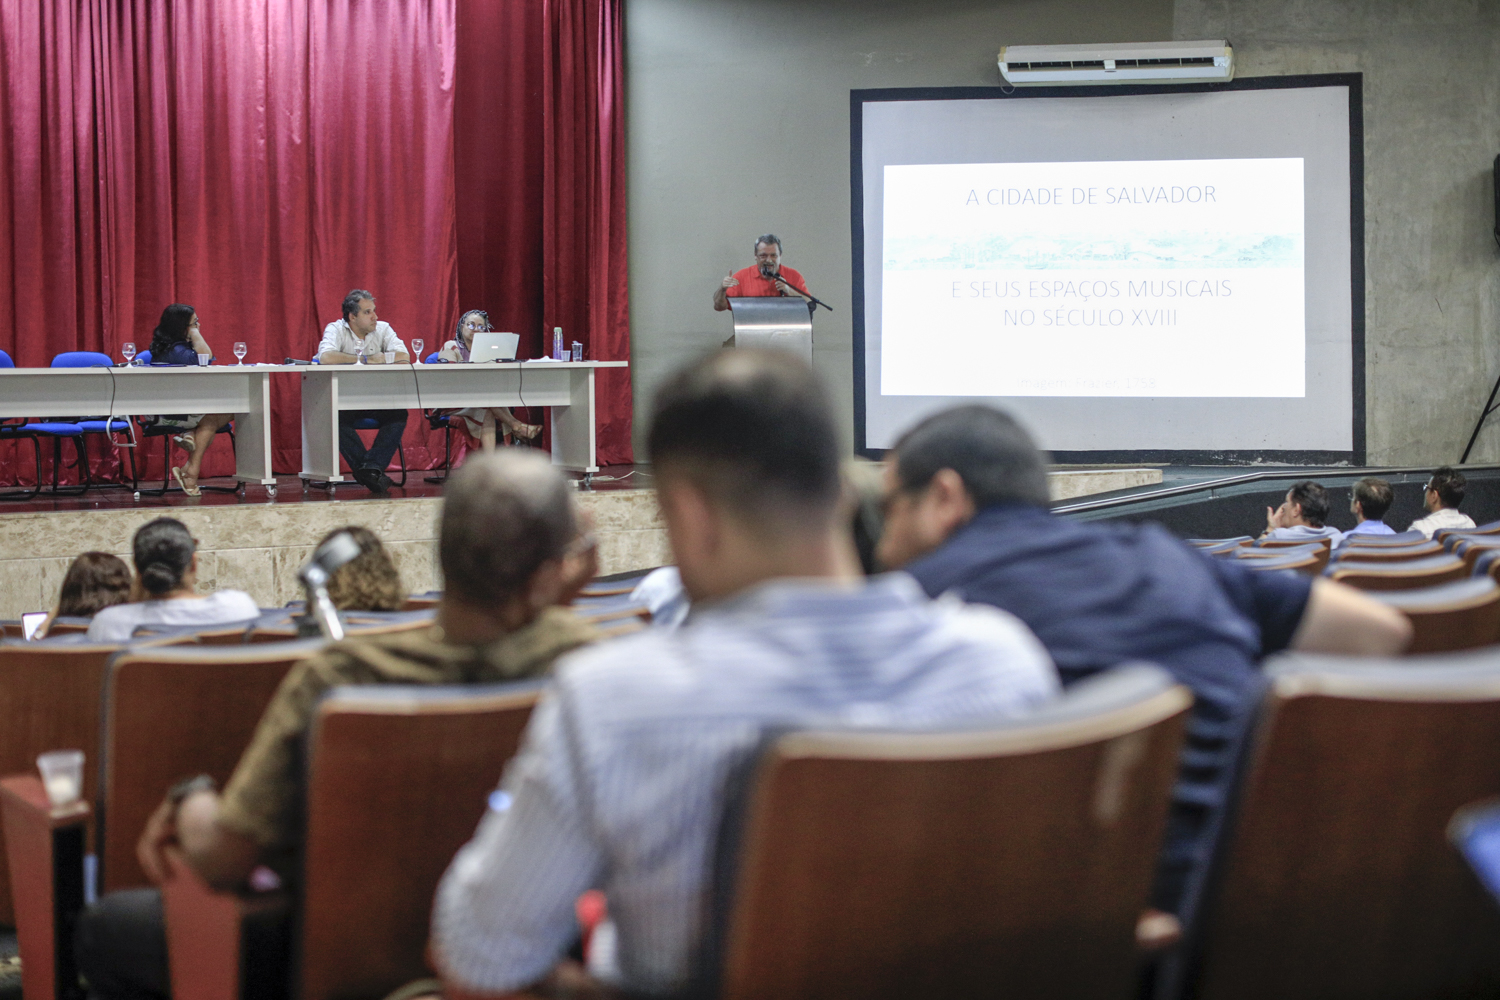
[0,364,279,496]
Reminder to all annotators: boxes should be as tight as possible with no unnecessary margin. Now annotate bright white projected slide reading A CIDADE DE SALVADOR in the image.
[879,157,1307,397]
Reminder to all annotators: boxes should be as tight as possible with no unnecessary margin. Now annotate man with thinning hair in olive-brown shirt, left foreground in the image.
[77,451,597,1000]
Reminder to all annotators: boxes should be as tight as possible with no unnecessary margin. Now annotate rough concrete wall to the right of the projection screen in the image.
[1175,0,1500,465]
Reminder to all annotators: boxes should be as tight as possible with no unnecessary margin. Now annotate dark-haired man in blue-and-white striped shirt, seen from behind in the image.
[432,349,1058,999]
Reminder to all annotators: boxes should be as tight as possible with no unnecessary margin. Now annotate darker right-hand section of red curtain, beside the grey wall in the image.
[455,0,633,465]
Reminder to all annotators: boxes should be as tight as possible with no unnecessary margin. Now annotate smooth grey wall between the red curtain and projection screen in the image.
[626,0,1172,457]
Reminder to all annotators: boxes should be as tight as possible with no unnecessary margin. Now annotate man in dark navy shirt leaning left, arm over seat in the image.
[878,406,1410,916]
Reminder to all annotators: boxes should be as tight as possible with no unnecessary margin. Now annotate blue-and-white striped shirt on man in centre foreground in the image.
[432,574,1058,993]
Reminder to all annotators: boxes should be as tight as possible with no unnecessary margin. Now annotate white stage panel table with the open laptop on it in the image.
[298,361,630,484]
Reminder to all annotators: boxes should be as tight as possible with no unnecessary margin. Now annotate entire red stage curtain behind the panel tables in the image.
[0,0,630,483]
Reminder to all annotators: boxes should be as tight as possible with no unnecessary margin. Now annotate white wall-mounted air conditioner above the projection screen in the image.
[1001,39,1235,87]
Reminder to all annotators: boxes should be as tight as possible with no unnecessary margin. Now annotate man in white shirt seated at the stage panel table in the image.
[318,288,411,493]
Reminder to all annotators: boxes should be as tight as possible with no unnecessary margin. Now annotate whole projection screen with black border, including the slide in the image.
[851,73,1365,465]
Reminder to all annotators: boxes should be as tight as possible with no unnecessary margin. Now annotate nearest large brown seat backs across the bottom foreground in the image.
[0,637,1500,1000]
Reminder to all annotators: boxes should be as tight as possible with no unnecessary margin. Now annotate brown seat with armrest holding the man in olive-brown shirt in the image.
[164,682,542,1000]
